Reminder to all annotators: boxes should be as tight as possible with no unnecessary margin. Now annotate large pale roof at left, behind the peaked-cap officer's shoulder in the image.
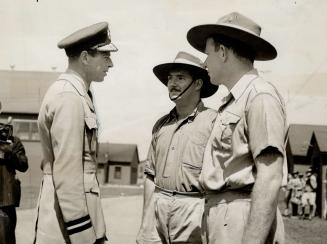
[0,70,60,113]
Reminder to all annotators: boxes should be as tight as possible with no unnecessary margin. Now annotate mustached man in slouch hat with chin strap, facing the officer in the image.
[137,52,218,244]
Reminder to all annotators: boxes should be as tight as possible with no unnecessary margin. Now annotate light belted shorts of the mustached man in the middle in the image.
[154,191,204,244]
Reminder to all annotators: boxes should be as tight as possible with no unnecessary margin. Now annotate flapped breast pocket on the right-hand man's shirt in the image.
[220,114,241,149]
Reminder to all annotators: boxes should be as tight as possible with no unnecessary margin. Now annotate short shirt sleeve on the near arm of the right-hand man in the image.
[247,93,286,159]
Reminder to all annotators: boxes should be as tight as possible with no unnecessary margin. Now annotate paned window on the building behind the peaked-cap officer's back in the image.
[12,119,40,141]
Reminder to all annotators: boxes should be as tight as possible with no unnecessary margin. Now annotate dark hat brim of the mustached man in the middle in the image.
[153,63,218,98]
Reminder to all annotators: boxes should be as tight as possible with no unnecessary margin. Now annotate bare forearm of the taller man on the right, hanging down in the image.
[243,153,282,244]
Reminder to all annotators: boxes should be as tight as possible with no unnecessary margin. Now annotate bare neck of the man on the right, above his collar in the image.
[223,59,253,91]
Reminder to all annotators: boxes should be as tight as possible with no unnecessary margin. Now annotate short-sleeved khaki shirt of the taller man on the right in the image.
[200,69,287,191]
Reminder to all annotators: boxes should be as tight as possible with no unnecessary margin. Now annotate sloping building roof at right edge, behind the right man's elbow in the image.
[288,124,327,156]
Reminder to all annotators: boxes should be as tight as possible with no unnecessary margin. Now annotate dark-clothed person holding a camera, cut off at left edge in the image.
[0,102,28,244]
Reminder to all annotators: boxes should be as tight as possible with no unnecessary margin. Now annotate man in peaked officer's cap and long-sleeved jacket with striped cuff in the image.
[34,22,117,244]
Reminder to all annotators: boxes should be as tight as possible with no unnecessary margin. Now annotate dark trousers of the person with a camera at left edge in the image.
[0,206,17,244]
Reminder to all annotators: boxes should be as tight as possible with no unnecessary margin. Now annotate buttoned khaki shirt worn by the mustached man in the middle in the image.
[145,102,216,192]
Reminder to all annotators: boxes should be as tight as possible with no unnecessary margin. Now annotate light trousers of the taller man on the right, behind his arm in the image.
[202,191,284,244]
